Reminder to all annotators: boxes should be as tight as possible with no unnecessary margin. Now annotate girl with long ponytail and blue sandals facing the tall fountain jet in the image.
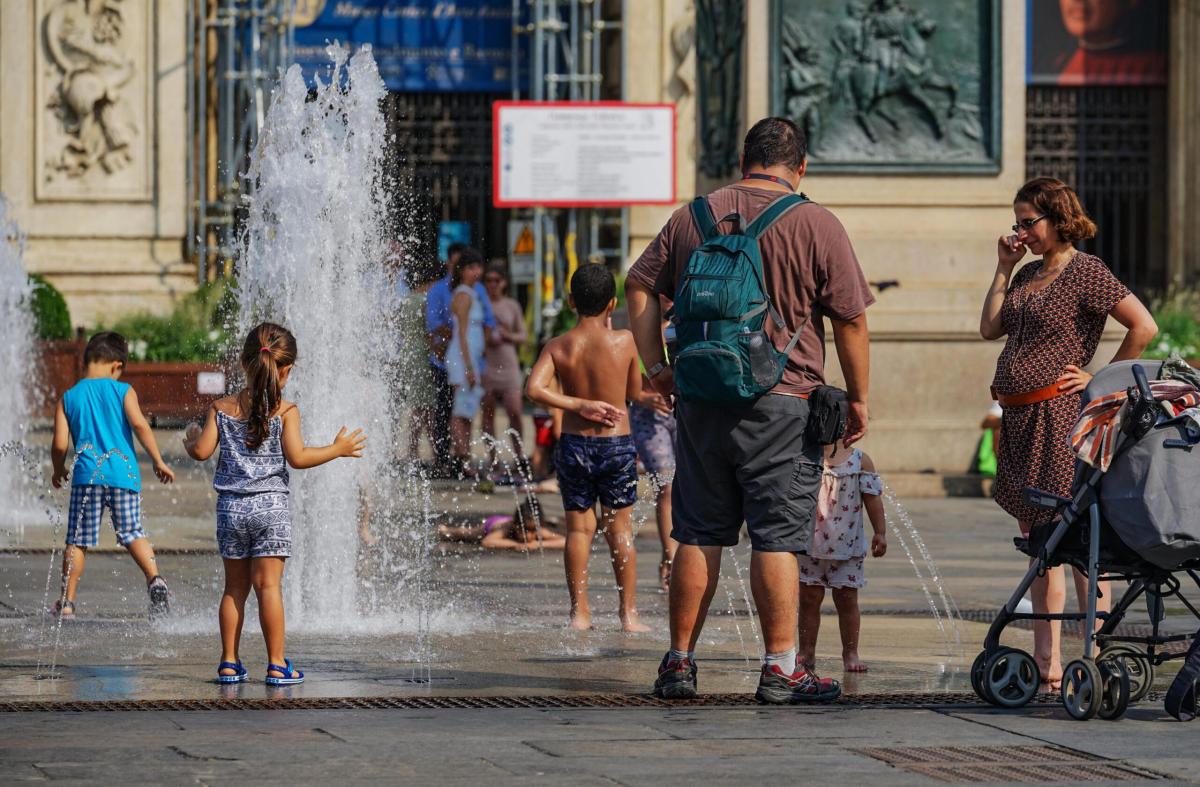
[184,323,366,686]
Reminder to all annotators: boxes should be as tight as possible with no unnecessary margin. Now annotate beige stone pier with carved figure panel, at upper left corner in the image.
[0,0,193,326]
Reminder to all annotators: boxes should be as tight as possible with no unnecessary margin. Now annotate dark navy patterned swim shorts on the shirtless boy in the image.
[554,434,637,511]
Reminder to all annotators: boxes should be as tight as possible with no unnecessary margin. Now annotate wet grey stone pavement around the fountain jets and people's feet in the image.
[0,434,1195,783]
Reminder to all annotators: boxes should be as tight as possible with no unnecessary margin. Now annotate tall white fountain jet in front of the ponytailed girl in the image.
[239,46,433,632]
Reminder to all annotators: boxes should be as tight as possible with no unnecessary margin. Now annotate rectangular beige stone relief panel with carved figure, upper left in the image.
[36,0,154,200]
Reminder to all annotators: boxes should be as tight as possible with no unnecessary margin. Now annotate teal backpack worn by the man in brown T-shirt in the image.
[671,194,809,404]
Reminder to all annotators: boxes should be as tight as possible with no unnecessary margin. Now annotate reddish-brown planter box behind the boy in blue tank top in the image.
[36,341,226,420]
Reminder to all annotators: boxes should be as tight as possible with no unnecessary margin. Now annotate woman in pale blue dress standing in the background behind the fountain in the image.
[446,250,487,474]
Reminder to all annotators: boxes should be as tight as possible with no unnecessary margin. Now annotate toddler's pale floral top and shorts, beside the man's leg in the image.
[799,449,883,588]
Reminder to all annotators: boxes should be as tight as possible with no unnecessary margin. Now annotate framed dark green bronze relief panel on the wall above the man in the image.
[773,0,1000,169]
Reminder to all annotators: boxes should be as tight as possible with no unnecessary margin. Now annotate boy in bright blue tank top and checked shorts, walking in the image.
[50,331,175,619]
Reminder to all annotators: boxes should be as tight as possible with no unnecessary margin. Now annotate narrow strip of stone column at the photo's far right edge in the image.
[1166,0,1200,286]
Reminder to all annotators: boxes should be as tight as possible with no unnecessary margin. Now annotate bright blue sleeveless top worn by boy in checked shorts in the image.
[62,377,142,492]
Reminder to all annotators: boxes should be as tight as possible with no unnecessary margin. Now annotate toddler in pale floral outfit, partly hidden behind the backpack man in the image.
[798,441,888,672]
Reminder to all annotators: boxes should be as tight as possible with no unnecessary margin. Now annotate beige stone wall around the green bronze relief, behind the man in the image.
[626,0,1200,474]
